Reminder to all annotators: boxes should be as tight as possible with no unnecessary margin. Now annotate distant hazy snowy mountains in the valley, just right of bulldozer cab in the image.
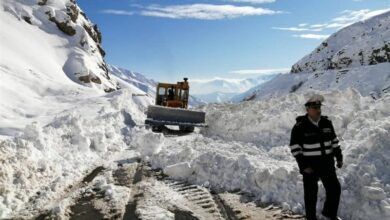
[191,74,276,103]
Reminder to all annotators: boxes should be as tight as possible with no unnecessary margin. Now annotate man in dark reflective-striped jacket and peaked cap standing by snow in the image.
[290,95,343,220]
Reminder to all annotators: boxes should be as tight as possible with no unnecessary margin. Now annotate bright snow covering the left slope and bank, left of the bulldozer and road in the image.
[0,6,153,213]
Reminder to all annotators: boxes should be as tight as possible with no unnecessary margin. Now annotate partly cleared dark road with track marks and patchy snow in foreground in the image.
[34,158,303,220]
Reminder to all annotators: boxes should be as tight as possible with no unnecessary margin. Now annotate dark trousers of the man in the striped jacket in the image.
[303,158,341,220]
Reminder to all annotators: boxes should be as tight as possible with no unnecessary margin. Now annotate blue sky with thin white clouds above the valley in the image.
[77,0,390,81]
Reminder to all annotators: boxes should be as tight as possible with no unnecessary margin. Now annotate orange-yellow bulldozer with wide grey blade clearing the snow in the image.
[145,78,207,132]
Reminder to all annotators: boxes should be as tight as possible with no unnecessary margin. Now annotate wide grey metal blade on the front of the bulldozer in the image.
[145,105,207,127]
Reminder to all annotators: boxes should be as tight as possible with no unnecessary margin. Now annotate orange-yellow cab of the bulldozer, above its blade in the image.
[156,78,190,109]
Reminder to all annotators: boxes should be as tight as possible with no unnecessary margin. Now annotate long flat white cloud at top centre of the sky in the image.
[140,4,281,20]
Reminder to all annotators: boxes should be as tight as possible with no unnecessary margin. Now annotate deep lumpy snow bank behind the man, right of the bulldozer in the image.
[136,89,390,220]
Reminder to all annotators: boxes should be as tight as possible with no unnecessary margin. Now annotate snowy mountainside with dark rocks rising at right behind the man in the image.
[241,12,390,101]
